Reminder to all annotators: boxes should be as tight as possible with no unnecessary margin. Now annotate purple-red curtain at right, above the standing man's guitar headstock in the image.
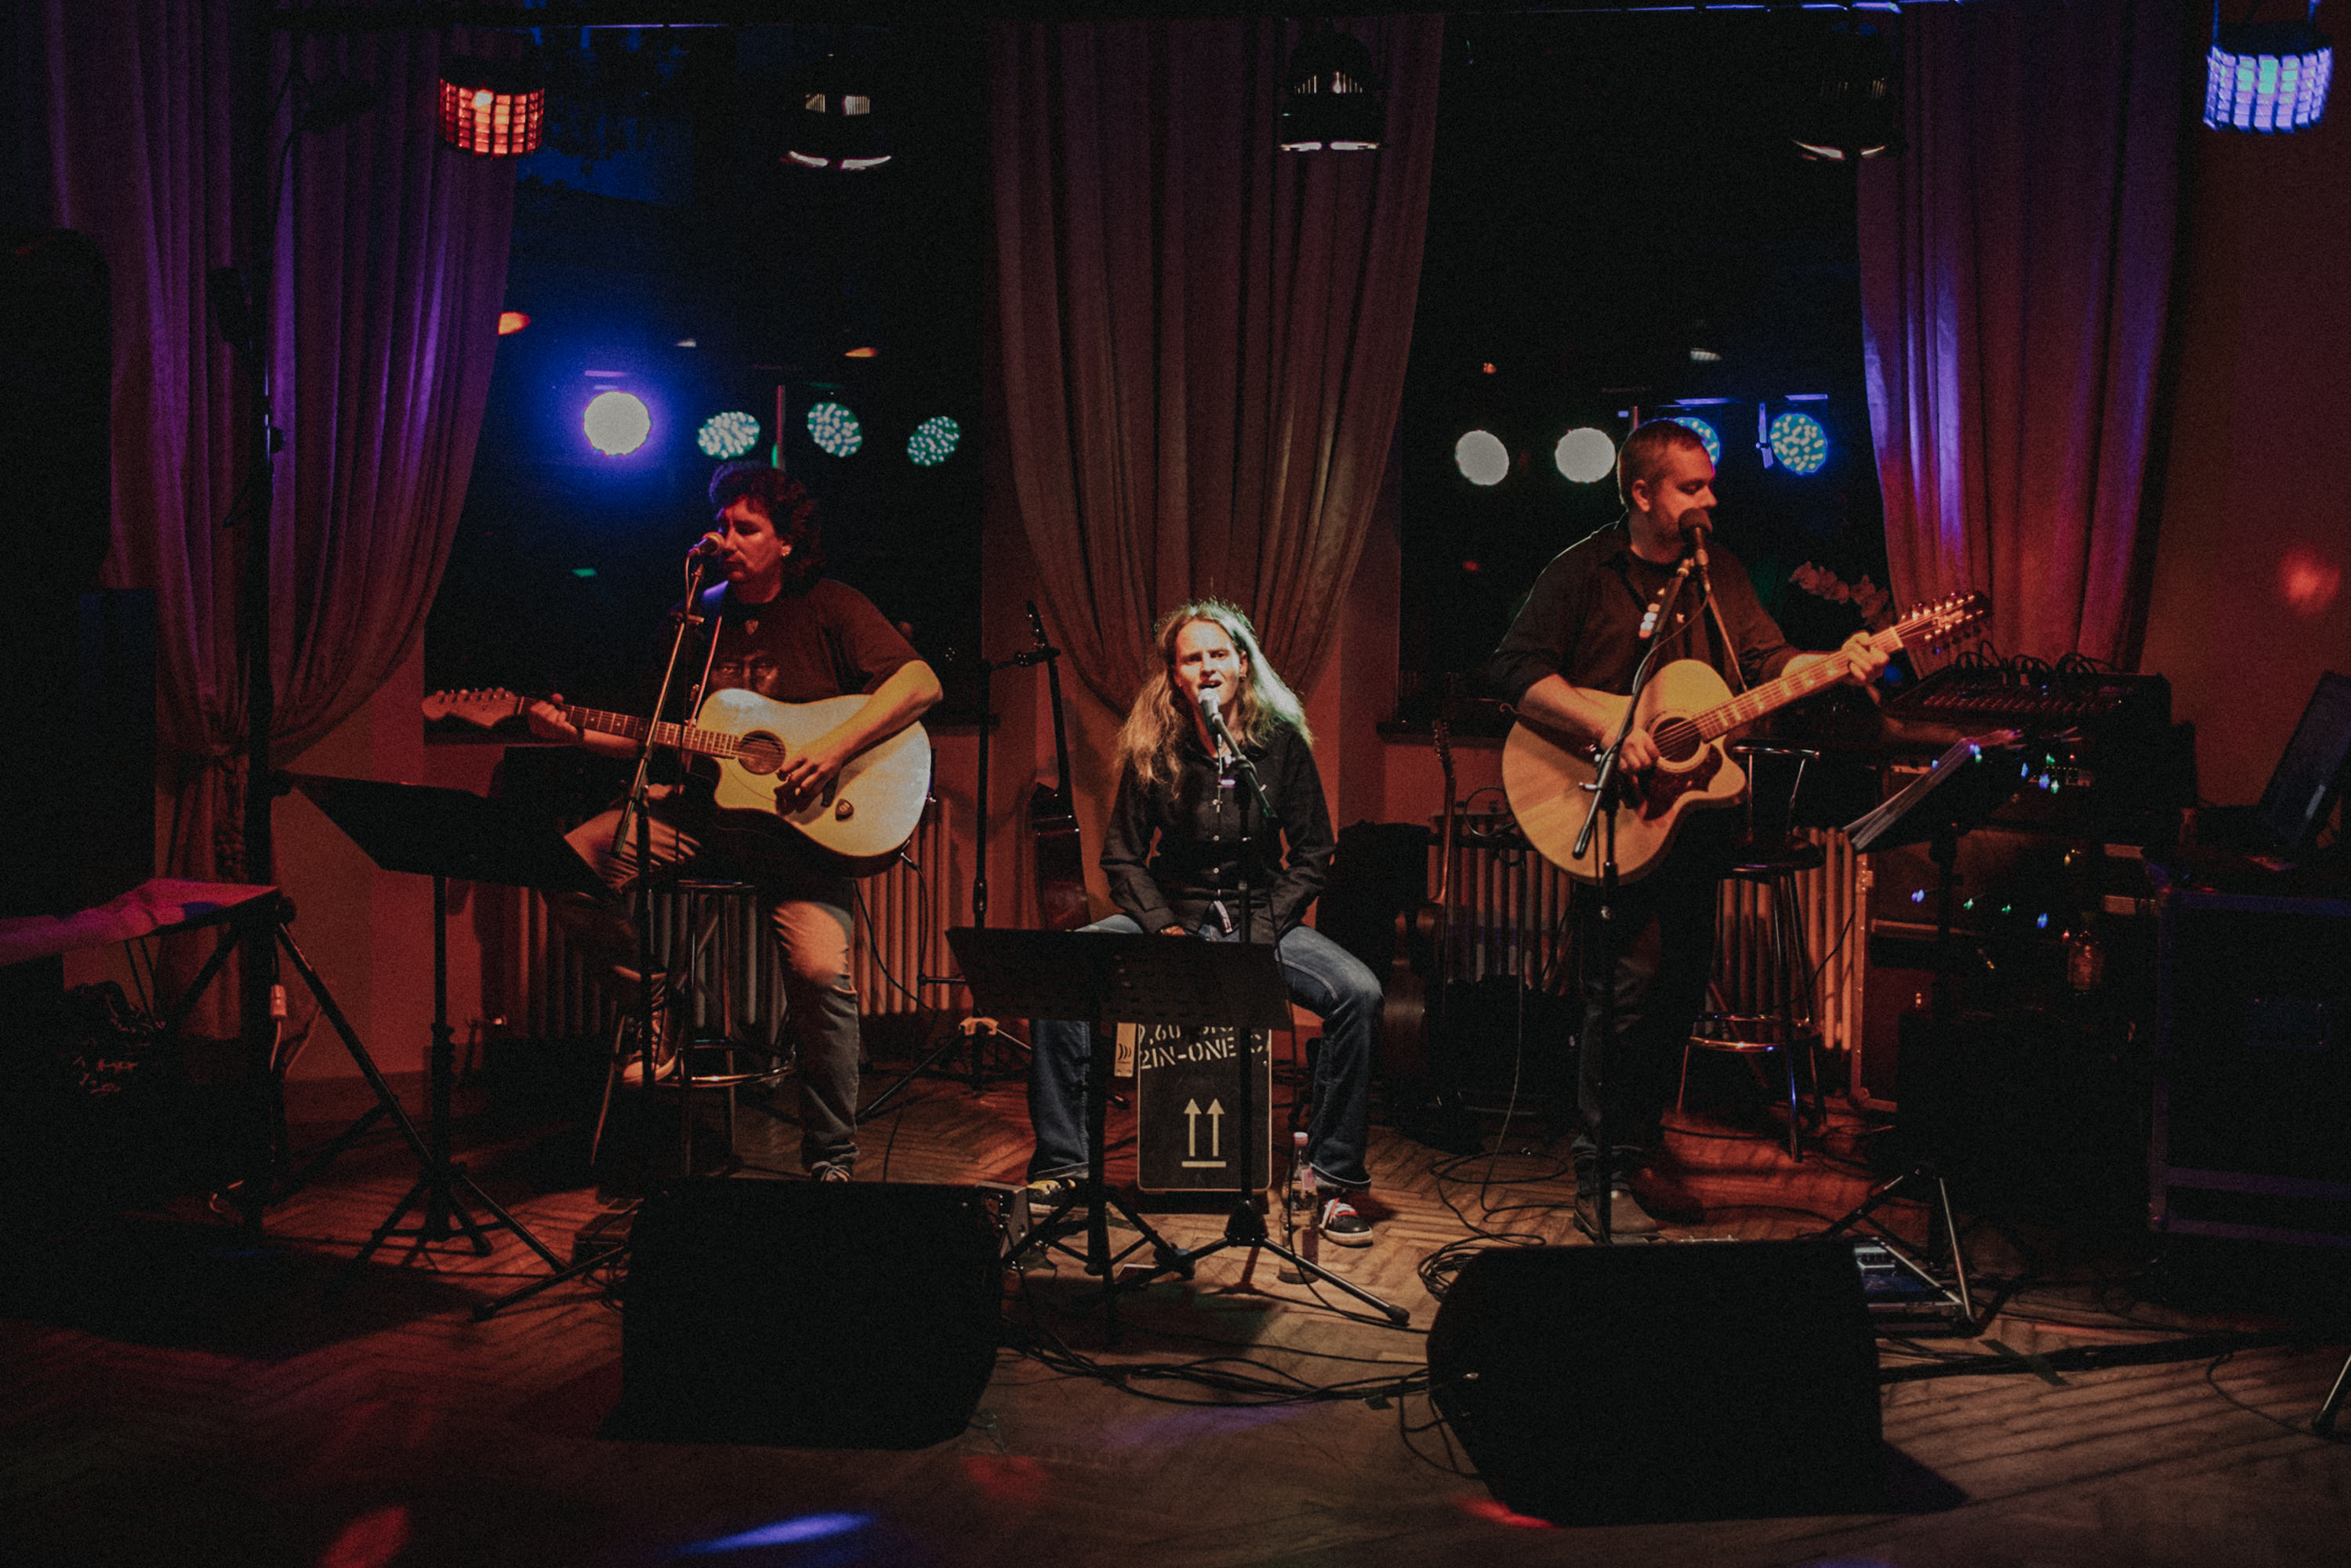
[1859,0,2186,663]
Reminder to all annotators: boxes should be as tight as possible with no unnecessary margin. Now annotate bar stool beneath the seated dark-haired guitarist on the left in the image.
[588,877,793,1175]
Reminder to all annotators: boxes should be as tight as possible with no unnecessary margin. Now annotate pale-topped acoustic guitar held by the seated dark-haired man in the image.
[423,689,931,877]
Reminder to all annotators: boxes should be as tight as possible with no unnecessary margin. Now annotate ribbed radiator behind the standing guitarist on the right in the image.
[1429,822,1864,1076]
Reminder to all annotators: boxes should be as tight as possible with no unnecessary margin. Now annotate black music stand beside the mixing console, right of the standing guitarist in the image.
[1819,729,2024,1335]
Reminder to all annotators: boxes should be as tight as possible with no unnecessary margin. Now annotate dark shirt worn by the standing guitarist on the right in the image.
[1486,520,1796,703]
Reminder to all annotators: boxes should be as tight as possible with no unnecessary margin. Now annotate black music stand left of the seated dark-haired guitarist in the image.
[292,774,604,1269]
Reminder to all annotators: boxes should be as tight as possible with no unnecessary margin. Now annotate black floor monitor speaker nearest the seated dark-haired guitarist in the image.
[611,1180,1002,1448]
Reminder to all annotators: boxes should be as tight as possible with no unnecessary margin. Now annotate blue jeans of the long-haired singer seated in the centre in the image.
[1030,914,1380,1187]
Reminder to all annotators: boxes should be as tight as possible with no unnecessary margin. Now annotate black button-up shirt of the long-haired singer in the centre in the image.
[1103,724,1337,942]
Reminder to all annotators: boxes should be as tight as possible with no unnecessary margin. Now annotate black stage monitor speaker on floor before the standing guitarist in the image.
[1429,1239,1885,1523]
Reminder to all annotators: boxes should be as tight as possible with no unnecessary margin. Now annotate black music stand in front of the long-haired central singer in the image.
[948,926,1410,1326]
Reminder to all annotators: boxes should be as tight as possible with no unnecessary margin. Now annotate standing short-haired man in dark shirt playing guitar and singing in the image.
[1486,419,1885,1234]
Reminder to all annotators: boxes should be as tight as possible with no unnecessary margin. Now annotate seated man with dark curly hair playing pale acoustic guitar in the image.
[529,463,941,1180]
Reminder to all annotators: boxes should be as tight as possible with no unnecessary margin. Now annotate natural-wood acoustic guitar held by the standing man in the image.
[1502,593,1991,881]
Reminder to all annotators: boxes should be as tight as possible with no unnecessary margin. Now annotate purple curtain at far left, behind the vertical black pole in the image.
[16,0,515,1025]
